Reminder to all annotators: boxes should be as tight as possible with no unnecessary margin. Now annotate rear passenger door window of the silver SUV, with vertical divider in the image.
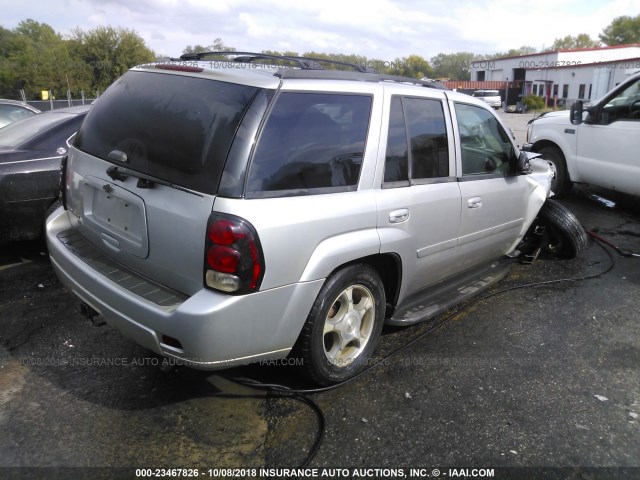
[384,97,449,183]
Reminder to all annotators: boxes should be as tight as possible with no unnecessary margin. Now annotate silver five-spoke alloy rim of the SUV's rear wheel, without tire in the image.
[323,285,375,368]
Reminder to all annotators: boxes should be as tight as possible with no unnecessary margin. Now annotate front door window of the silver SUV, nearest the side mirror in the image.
[455,103,515,175]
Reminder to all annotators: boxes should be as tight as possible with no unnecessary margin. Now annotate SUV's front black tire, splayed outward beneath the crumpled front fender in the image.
[536,199,588,258]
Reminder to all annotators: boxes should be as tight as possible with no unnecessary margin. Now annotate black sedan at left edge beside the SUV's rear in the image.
[0,106,89,243]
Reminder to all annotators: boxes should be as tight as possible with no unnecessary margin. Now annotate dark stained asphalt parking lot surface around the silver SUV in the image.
[0,109,640,478]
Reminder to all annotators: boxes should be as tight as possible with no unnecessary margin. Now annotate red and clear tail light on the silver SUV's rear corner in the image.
[204,213,264,295]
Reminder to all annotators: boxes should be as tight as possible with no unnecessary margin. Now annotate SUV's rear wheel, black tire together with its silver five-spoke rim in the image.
[292,264,386,385]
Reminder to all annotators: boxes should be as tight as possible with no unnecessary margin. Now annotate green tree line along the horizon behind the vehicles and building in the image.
[0,15,640,100]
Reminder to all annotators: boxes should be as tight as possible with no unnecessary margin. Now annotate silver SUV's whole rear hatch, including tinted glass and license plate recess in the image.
[66,69,276,295]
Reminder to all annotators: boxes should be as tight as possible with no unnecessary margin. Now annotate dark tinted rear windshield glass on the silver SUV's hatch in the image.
[75,71,258,194]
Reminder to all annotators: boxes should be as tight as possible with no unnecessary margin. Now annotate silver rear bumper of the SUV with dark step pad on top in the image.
[46,208,323,370]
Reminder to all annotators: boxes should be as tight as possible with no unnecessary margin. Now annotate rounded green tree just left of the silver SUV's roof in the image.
[70,26,155,91]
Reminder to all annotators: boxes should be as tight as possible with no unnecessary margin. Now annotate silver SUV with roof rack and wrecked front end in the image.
[47,52,586,384]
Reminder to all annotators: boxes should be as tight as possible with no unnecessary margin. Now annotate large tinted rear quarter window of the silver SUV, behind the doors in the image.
[247,92,371,195]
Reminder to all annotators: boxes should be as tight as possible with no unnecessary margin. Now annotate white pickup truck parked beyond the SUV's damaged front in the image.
[523,73,640,196]
